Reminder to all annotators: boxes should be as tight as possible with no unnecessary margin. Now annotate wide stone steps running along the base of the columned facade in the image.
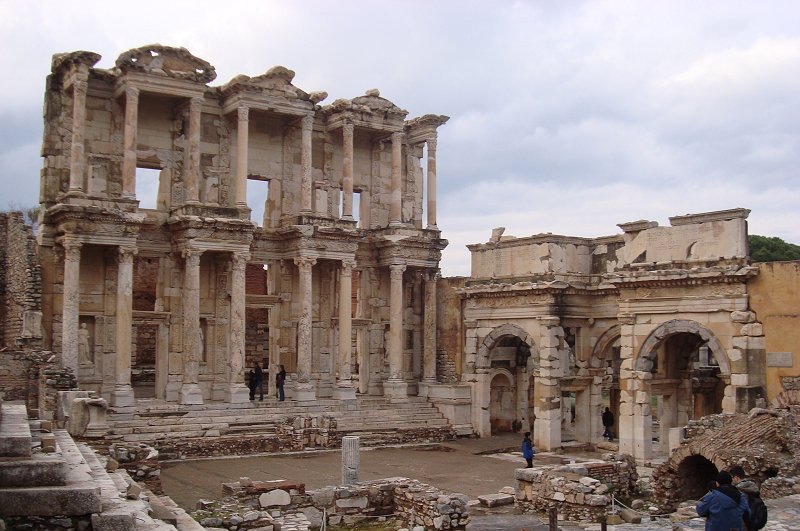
[105,396,453,454]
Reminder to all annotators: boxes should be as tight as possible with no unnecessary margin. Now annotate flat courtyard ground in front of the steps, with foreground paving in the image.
[161,434,800,531]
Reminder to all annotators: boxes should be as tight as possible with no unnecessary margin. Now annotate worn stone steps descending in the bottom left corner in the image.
[0,402,203,531]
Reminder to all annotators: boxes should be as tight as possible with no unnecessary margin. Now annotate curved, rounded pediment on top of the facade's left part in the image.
[116,44,217,84]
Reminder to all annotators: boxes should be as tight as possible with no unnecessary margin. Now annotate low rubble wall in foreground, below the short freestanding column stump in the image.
[192,478,469,531]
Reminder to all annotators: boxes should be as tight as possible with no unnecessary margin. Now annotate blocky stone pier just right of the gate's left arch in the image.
[534,316,564,451]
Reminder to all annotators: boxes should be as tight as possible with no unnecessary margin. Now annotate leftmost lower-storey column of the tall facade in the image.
[61,239,82,376]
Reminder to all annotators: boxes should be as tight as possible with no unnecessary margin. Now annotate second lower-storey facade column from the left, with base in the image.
[111,246,136,407]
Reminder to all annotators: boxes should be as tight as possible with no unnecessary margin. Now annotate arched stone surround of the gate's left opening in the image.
[472,323,539,437]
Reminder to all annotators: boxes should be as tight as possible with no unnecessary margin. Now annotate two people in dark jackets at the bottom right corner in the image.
[696,465,767,531]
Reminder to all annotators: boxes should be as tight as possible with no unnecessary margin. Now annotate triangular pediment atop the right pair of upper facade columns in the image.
[321,89,408,132]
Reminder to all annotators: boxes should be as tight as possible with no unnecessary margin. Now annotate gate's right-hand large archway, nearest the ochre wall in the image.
[636,319,730,453]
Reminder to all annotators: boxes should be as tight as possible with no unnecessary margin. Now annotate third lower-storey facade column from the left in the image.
[180,249,203,404]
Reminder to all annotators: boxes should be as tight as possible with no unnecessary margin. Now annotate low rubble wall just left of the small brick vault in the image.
[515,454,639,522]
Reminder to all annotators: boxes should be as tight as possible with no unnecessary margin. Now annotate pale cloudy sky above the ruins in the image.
[0,0,800,276]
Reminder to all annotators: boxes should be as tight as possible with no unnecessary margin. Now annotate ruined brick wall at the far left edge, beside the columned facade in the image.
[0,212,42,347]
